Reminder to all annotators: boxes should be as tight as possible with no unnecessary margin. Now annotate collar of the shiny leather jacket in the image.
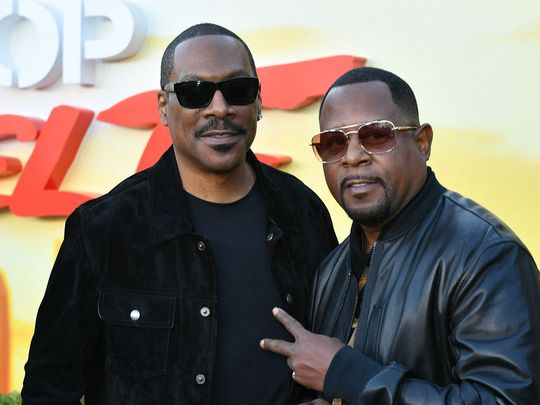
[351,167,446,245]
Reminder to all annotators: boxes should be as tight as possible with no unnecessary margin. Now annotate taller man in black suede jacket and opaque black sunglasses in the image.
[22,24,337,405]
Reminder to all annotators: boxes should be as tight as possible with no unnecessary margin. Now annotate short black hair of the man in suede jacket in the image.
[161,23,257,89]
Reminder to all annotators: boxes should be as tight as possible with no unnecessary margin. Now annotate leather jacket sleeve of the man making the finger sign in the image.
[324,240,540,405]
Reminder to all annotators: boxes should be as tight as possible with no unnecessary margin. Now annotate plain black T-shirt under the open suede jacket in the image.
[189,183,292,405]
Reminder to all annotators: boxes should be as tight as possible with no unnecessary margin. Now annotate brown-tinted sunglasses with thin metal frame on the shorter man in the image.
[311,120,418,163]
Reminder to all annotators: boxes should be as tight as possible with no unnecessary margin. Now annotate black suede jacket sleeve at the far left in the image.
[21,211,99,405]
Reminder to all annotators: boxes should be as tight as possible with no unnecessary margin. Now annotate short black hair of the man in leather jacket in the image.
[319,67,420,125]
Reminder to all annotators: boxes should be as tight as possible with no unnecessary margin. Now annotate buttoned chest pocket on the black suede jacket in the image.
[98,290,176,379]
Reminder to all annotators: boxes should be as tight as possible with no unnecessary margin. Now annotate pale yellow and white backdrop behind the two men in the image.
[0,0,540,390]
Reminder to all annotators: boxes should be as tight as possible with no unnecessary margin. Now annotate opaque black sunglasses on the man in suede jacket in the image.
[163,77,260,108]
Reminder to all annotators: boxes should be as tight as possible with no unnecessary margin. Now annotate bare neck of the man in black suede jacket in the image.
[176,158,256,204]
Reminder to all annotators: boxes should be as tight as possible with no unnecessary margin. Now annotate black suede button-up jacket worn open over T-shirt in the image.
[22,149,337,405]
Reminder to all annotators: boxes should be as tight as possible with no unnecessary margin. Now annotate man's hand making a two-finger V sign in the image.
[260,308,344,392]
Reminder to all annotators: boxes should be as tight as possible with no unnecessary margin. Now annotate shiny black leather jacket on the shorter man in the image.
[311,171,540,405]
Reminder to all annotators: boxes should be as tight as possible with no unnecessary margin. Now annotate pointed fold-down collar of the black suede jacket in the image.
[149,146,298,244]
